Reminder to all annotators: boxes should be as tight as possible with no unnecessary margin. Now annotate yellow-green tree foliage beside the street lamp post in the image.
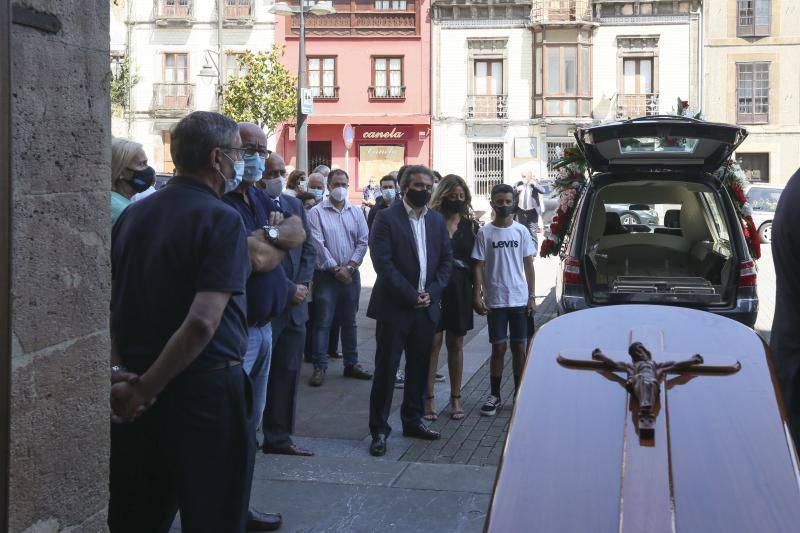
[222,45,297,135]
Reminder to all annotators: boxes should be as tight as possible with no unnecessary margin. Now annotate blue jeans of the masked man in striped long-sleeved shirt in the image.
[312,270,361,369]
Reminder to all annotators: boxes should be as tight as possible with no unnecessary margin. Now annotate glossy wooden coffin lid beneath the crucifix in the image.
[486,305,800,533]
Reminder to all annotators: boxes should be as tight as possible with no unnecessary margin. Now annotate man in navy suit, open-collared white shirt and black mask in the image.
[367,165,453,456]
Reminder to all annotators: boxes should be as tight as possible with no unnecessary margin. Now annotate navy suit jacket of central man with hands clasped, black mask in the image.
[367,201,453,322]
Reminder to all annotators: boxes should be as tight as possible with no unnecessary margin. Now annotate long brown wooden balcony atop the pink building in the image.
[291,0,420,37]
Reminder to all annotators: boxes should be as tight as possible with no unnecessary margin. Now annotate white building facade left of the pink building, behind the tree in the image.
[111,0,275,170]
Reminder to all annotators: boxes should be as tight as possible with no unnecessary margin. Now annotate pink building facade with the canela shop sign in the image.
[275,0,431,201]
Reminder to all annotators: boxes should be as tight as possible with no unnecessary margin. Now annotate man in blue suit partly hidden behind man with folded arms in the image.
[261,152,315,456]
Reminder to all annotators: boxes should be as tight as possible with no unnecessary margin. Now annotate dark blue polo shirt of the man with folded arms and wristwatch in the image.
[222,187,291,326]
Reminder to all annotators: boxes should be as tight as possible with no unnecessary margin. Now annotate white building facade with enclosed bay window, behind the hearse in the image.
[432,0,702,210]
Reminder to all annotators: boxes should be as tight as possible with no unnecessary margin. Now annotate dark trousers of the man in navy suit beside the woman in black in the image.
[369,309,436,436]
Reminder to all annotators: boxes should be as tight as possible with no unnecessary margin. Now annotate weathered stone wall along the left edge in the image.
[9,0,110,532]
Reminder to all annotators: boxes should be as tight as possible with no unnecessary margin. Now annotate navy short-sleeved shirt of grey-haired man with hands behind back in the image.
[111,177,250,373]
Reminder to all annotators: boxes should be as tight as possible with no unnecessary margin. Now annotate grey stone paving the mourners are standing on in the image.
[173,248,775,533]
